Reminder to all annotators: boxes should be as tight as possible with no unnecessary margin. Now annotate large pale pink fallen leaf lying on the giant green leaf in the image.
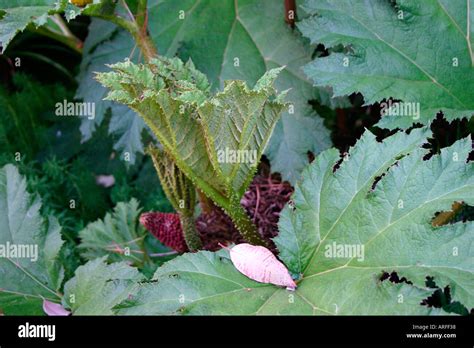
[226,243,296,290]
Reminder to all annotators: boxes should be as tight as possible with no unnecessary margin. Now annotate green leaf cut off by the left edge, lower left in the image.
[0,164,64,314]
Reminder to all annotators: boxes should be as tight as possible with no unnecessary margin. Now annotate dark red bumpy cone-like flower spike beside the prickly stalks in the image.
[140,212,188,253]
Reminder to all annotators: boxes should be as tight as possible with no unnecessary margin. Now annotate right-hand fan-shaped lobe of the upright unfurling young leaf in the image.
[198,68,285,197]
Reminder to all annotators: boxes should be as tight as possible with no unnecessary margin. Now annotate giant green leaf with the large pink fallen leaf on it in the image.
[113,129,474,315]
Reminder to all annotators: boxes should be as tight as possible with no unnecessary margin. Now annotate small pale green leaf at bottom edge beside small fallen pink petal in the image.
[63,257,144,315]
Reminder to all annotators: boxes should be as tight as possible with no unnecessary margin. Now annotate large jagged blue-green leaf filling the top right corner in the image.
[298,0,474,129]
